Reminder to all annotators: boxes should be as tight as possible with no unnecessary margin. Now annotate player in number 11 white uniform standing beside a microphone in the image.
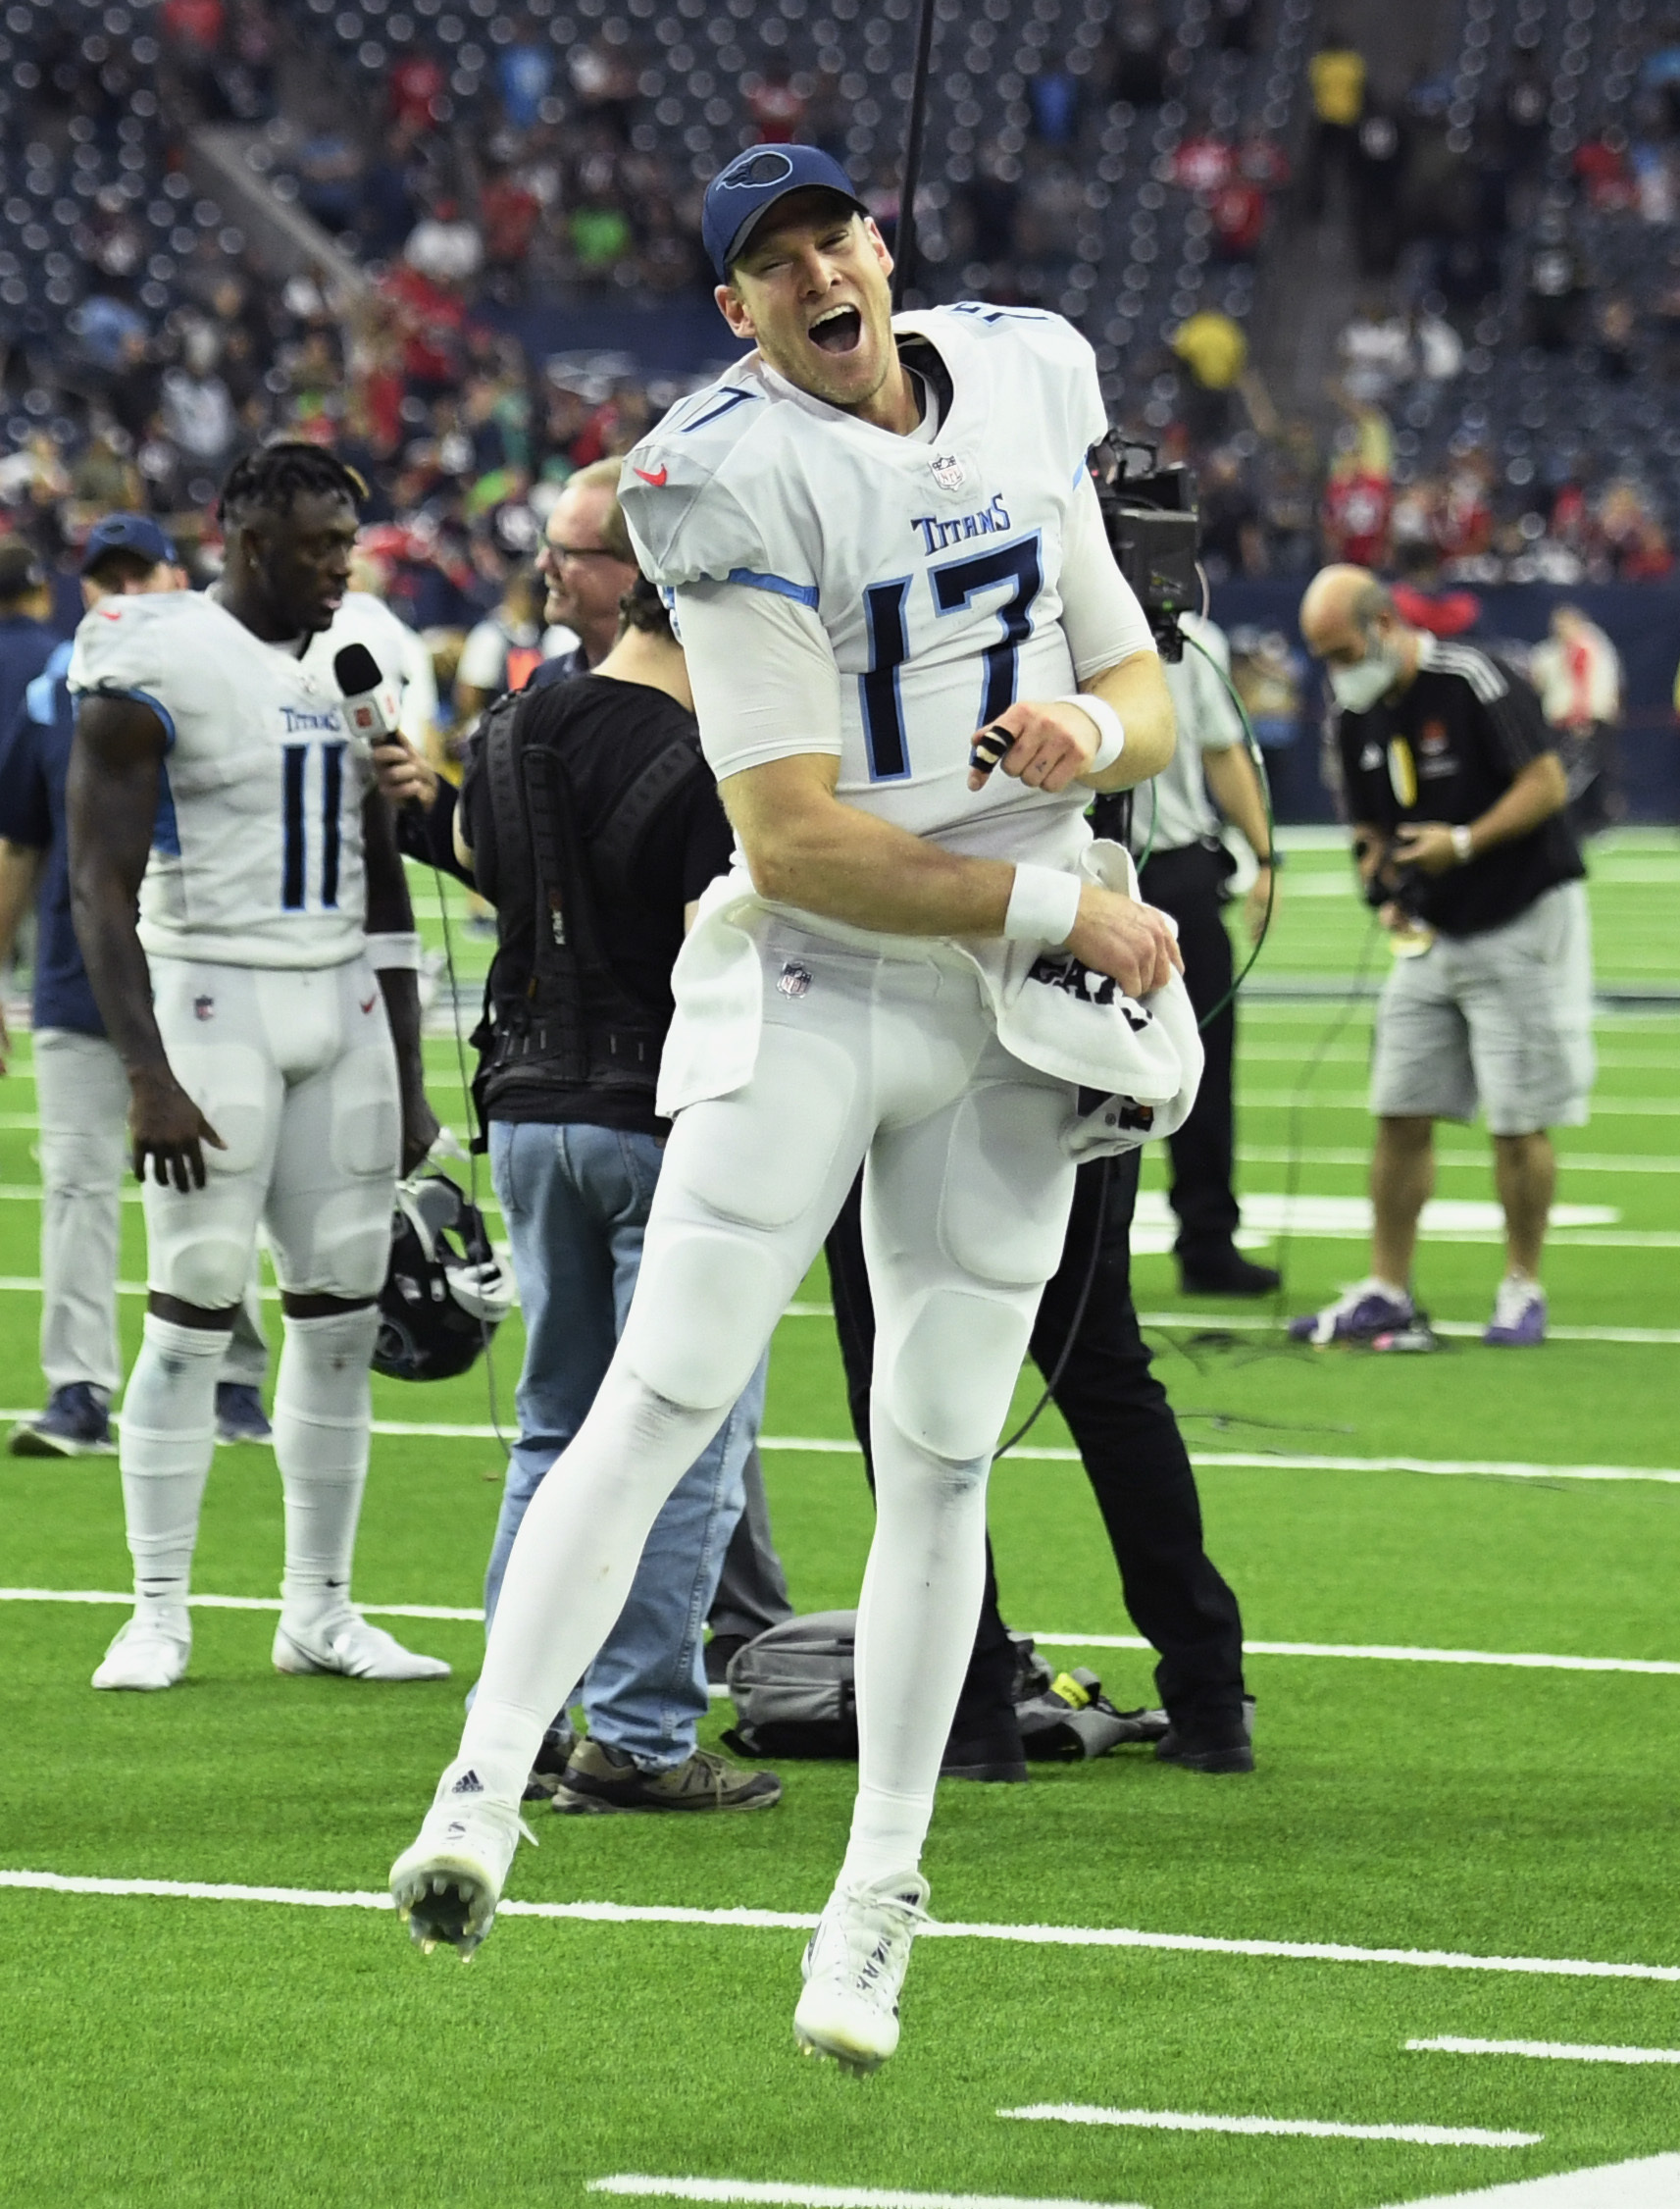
[69,444,448,1688]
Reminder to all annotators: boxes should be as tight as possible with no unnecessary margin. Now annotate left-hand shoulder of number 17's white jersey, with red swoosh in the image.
[618,362,817,603]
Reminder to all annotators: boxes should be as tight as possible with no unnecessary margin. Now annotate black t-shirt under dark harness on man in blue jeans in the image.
[459,676,733,1136]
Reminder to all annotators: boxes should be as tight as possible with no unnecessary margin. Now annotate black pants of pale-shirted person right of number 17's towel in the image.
[1137,844,1239,1270]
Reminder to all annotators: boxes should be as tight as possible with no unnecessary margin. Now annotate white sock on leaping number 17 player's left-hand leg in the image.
[450,1365,719,1803]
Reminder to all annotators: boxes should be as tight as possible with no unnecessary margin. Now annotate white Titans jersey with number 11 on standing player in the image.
[69,590,377,967]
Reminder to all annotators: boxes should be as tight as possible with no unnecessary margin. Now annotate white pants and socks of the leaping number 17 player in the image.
[461,919,1075,1877]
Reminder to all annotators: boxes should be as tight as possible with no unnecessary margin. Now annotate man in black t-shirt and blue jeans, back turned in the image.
[455,552,782,1812]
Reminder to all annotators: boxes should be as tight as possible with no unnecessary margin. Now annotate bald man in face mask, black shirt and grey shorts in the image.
[1290,566,1594,1350]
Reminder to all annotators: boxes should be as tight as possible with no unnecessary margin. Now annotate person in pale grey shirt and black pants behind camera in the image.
[1126,614,1278,1297]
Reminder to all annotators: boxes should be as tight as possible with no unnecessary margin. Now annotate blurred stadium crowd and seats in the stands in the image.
[0,0,1680,706]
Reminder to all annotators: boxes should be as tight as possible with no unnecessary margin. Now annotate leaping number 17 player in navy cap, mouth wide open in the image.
[390,146,1198,2070]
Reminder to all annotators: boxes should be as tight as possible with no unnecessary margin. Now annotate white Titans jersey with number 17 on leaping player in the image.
[621,305,1152,864]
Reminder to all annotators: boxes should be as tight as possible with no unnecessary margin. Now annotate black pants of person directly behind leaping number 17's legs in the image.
[828,1151,1243,1736]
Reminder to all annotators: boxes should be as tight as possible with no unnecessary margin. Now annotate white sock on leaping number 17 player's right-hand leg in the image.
[841,1412,992,1886]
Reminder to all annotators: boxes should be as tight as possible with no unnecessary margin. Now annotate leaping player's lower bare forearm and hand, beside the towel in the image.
[718,753,1184,997]
